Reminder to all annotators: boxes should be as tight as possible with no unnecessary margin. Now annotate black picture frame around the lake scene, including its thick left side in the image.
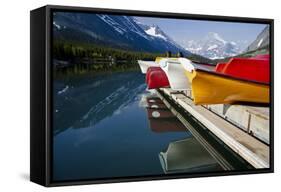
[30,5,274,187]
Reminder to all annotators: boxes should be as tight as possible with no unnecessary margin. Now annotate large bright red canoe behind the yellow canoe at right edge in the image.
[215,55,270,83]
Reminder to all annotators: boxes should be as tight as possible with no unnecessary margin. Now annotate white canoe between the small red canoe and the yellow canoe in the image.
[159,58,190,91]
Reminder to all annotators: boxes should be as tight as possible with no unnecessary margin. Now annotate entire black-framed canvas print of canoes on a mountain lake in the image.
[30,5,274,186]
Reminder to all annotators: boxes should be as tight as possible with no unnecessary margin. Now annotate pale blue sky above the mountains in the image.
[137,17,266,44]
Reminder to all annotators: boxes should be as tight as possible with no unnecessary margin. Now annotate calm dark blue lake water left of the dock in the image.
[53,72,220,181]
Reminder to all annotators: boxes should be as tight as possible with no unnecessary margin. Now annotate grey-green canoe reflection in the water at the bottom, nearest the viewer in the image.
[159,137,221,173]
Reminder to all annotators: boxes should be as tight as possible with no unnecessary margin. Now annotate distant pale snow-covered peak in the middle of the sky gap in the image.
[185,32,243,59]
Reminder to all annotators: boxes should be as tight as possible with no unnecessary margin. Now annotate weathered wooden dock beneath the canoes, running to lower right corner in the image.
[158,88,270,168]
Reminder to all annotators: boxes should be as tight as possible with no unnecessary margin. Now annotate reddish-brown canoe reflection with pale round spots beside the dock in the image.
[146,97,187,133]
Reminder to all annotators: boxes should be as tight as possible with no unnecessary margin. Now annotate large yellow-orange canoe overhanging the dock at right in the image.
[185,69,270,105]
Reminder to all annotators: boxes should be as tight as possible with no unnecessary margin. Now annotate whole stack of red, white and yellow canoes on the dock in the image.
[138,55,270,105]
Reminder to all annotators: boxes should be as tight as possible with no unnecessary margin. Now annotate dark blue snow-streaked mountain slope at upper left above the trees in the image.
[53,13,190,55]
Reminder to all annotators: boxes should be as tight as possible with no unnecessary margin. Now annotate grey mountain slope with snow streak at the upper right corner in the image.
[245,26,269,52]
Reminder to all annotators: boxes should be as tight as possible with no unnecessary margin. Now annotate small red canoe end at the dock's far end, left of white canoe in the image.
[146,67,170,89]
